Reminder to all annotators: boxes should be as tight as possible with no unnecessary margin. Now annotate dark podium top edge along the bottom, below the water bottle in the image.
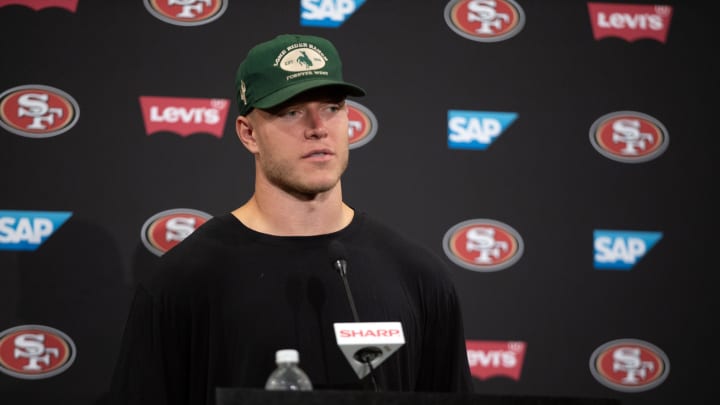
[215,387,620,405]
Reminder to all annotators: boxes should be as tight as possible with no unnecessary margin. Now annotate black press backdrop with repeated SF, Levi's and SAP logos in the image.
[0,0,718,405]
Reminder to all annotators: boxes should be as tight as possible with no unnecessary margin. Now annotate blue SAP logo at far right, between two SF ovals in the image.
[593,230,662,270]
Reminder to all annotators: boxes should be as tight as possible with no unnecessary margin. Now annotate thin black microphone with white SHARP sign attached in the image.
[328,239,405,391]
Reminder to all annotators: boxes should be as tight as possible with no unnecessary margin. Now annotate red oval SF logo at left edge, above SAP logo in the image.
[0,84,80,138]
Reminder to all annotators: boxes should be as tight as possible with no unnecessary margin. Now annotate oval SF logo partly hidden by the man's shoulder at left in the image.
[140,208,211,256]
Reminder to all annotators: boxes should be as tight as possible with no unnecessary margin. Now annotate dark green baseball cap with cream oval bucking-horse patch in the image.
[235,34,365,115]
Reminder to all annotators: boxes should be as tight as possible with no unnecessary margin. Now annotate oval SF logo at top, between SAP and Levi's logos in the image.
[445,0,525,42]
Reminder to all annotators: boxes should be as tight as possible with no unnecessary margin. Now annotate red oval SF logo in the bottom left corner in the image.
[0,325,76,380]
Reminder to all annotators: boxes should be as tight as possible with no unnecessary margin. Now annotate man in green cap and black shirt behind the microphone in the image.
[112,35,472,405]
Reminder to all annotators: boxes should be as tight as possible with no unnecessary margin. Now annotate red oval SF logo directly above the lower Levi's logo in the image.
[443,219,524,273]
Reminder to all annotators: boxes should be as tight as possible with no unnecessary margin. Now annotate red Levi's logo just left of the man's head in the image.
[140,96,230,138]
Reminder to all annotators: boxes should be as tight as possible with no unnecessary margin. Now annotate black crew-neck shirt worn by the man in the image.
[112,214,472,405]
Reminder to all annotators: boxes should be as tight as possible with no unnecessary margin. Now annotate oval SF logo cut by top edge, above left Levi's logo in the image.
[143,0,229,26]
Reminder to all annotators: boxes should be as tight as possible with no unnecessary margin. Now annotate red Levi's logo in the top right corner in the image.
[588,3,673,44]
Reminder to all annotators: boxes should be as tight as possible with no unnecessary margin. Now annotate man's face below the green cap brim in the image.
[240,88,349,198]
